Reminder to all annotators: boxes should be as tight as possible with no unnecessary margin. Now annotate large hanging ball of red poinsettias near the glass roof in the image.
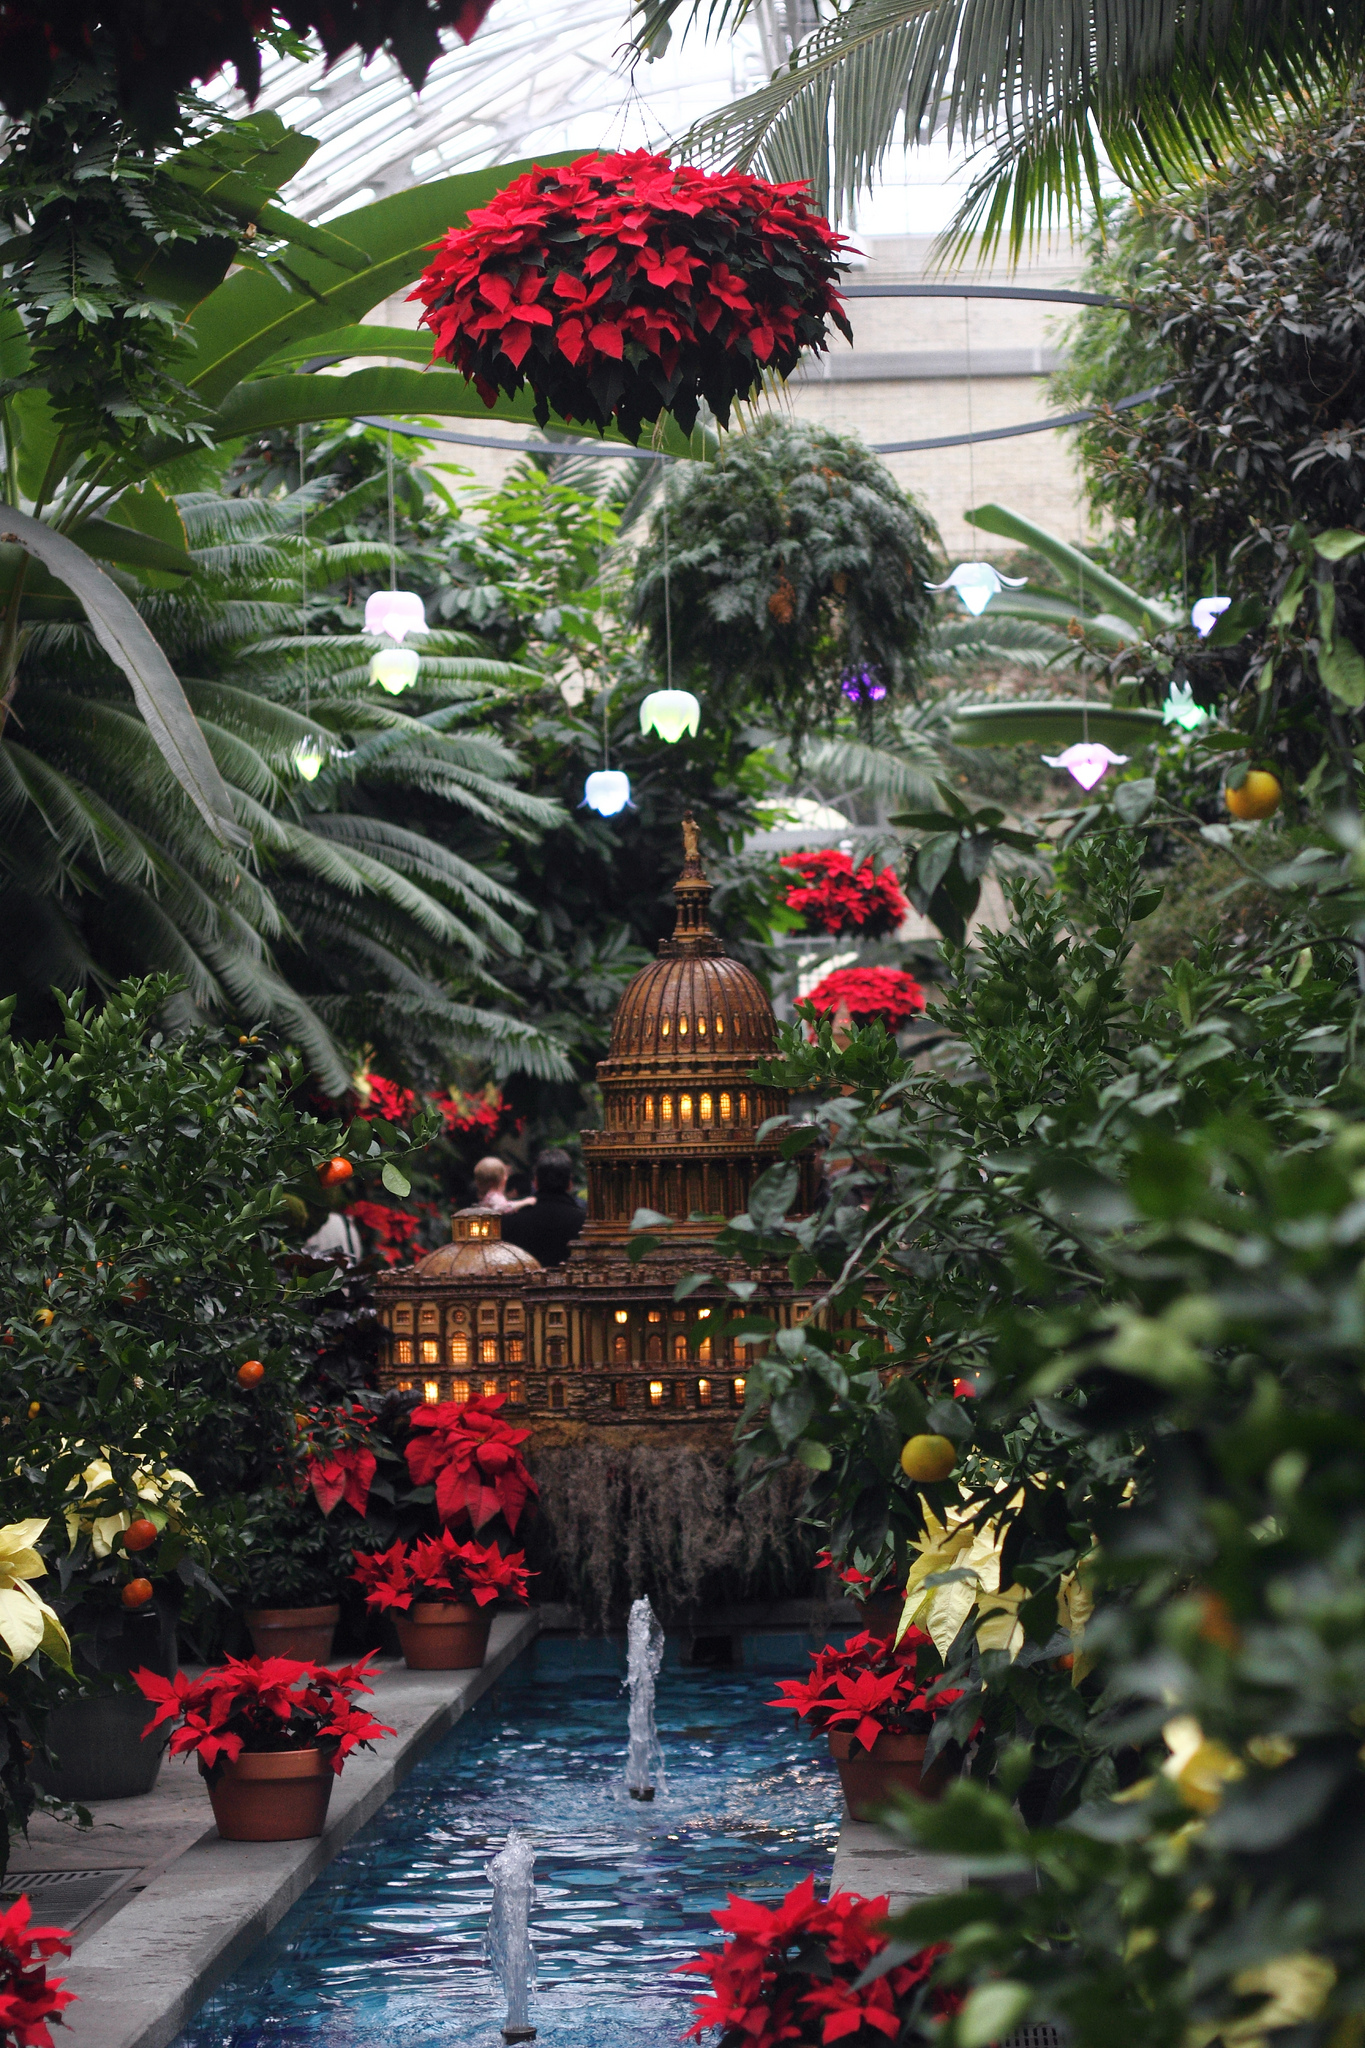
[413,150,851,440]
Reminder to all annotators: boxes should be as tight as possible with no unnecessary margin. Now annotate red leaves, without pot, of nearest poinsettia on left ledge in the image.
[133,1657,395,1778]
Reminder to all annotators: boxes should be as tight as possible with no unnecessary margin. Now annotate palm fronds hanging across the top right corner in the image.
[650,0,1363,254]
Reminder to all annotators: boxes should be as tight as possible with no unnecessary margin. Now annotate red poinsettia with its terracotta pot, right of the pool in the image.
[767,1628,962,1821]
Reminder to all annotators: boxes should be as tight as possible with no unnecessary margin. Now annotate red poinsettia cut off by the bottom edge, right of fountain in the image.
[679,1876,962,2048]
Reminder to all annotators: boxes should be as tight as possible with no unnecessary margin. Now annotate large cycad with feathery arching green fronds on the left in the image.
[0,479,563,1092]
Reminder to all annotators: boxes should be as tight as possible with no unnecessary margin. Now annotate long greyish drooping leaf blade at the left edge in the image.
[0,506,246,846]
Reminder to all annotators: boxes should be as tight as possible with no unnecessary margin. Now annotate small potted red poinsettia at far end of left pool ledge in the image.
[352,1530,528,1671]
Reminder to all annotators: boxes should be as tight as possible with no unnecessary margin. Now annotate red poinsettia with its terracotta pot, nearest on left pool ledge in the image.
[133,1657,393,1841]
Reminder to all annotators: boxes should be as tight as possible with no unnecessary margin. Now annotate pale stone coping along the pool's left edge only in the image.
[63,1608,540,2048]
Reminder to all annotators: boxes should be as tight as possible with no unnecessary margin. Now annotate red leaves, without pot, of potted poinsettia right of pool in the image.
[767,1628,962,1751]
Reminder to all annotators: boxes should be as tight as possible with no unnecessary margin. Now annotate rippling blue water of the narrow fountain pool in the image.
[174,1638,839,2048]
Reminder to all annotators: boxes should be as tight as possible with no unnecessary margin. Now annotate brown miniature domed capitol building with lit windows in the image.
[377,817,812,1442]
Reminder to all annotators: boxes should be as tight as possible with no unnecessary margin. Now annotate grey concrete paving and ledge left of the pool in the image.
[15,1608,540,2048]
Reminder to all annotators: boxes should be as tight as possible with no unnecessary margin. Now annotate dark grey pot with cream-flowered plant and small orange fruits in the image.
[33,1444,200,1800]
